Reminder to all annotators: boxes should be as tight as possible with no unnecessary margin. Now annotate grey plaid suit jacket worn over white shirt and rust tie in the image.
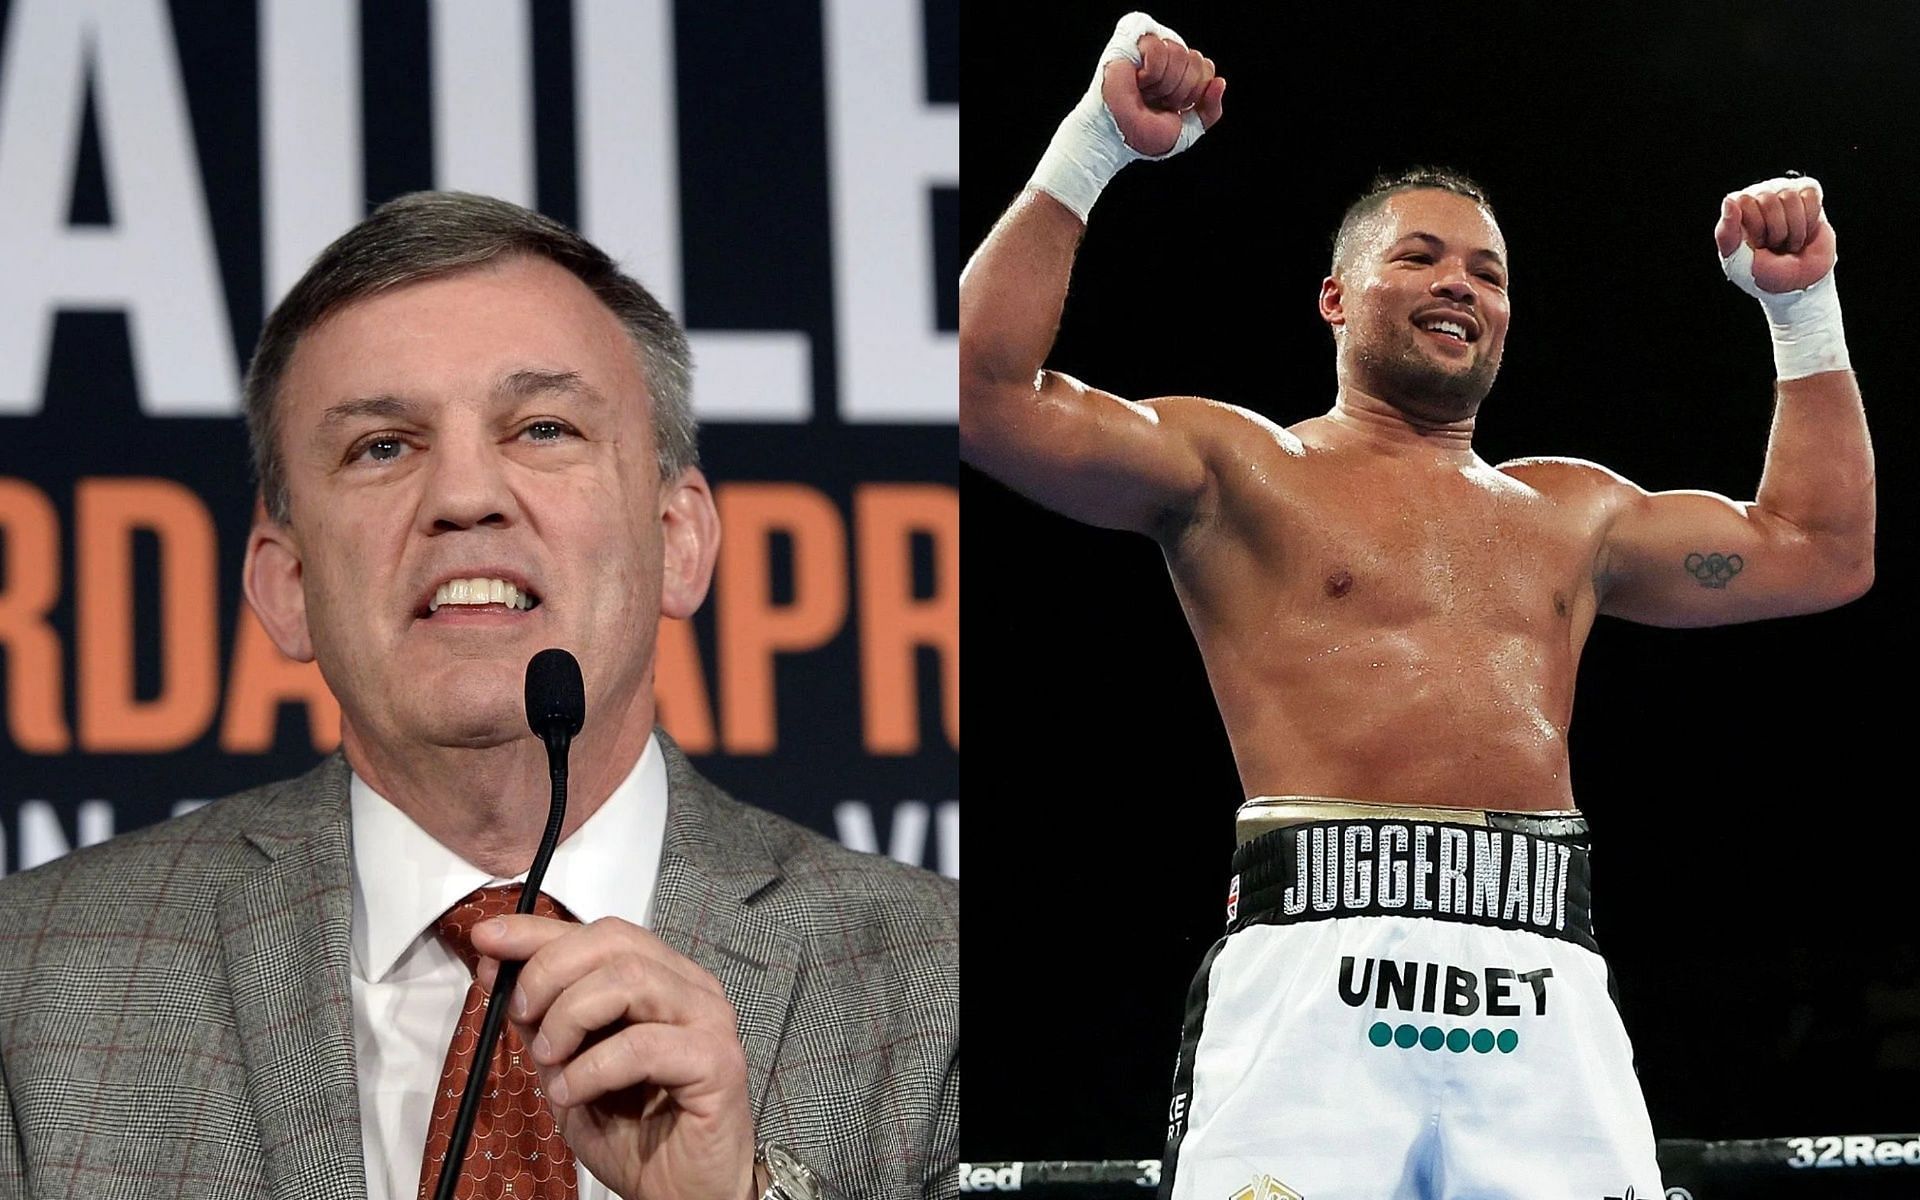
[0,733,960,1200]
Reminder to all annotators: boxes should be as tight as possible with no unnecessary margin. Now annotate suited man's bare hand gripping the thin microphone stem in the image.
[474,916,756,1200]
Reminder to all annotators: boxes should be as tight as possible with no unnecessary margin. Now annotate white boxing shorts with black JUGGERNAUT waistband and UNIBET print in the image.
[1160,801,1665,1200]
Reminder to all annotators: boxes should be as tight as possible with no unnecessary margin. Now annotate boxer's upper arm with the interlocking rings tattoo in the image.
[1599,484,1853,626]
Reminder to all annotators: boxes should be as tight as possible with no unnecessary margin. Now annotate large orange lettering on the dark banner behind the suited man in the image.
[0,476,960,755]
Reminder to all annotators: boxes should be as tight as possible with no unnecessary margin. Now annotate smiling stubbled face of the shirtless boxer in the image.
[1321,188,1507,422]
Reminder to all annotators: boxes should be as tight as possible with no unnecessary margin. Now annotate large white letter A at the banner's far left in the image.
[0,0,240,417]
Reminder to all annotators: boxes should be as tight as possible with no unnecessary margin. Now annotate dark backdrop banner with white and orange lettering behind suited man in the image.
[0,0,960,876]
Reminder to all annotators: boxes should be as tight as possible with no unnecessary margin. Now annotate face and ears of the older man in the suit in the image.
[248,257,712,747]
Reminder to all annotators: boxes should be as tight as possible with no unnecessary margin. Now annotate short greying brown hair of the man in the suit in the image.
[244,192,699,522]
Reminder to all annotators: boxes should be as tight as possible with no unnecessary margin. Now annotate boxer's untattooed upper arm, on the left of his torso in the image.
[962,371,1210,534]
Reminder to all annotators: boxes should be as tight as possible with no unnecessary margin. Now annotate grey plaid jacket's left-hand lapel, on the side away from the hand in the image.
[221,756,367,1200]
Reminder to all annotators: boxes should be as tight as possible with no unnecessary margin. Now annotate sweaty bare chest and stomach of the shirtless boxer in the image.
[1160,401,1605,810]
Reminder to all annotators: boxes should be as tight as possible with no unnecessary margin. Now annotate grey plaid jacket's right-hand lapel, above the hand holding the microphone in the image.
[651,730,801,1114]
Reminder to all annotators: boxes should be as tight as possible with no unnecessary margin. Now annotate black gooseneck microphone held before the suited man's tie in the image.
[434,649,588,1200]
